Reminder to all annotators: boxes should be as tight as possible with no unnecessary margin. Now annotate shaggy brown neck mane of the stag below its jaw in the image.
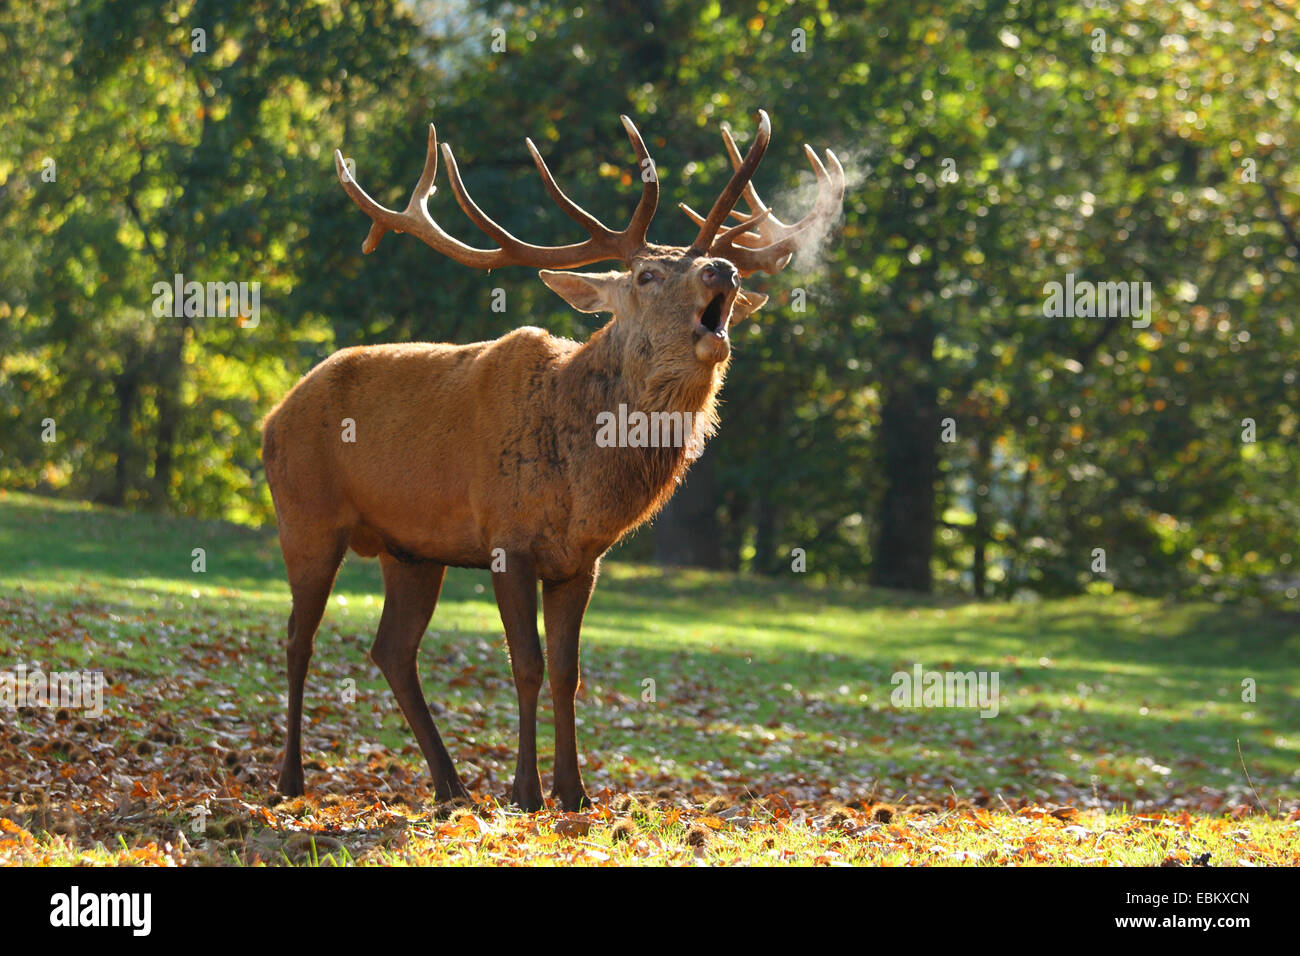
[560,320,727,527]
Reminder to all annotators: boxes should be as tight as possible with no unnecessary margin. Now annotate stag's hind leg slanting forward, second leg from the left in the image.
[371,554,469,801]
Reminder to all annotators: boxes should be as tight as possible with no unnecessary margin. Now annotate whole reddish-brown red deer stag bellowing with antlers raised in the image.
[263,112,844,810]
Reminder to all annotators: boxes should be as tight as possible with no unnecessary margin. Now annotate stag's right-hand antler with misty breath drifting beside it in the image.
[681,109,845,276]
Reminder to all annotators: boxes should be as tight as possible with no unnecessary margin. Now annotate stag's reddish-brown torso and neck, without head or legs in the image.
[263,323,724,581]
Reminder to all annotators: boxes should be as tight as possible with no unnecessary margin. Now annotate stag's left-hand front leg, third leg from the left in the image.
[491,554,543,813]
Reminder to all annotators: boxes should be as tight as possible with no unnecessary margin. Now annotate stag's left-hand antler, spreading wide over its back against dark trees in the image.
[334,116,659,269]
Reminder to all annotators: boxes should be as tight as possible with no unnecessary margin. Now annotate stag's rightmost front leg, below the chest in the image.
[542,566,597,810]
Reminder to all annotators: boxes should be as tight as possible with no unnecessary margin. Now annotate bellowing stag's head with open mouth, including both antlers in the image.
[334,111,844,371]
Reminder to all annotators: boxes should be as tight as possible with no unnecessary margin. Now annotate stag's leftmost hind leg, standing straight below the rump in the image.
[280,528,347,796]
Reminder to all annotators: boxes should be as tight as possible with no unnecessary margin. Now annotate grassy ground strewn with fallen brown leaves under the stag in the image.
[0,494,1300,865]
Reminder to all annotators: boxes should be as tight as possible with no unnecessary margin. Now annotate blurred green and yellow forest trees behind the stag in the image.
[0,0,1300,602]
